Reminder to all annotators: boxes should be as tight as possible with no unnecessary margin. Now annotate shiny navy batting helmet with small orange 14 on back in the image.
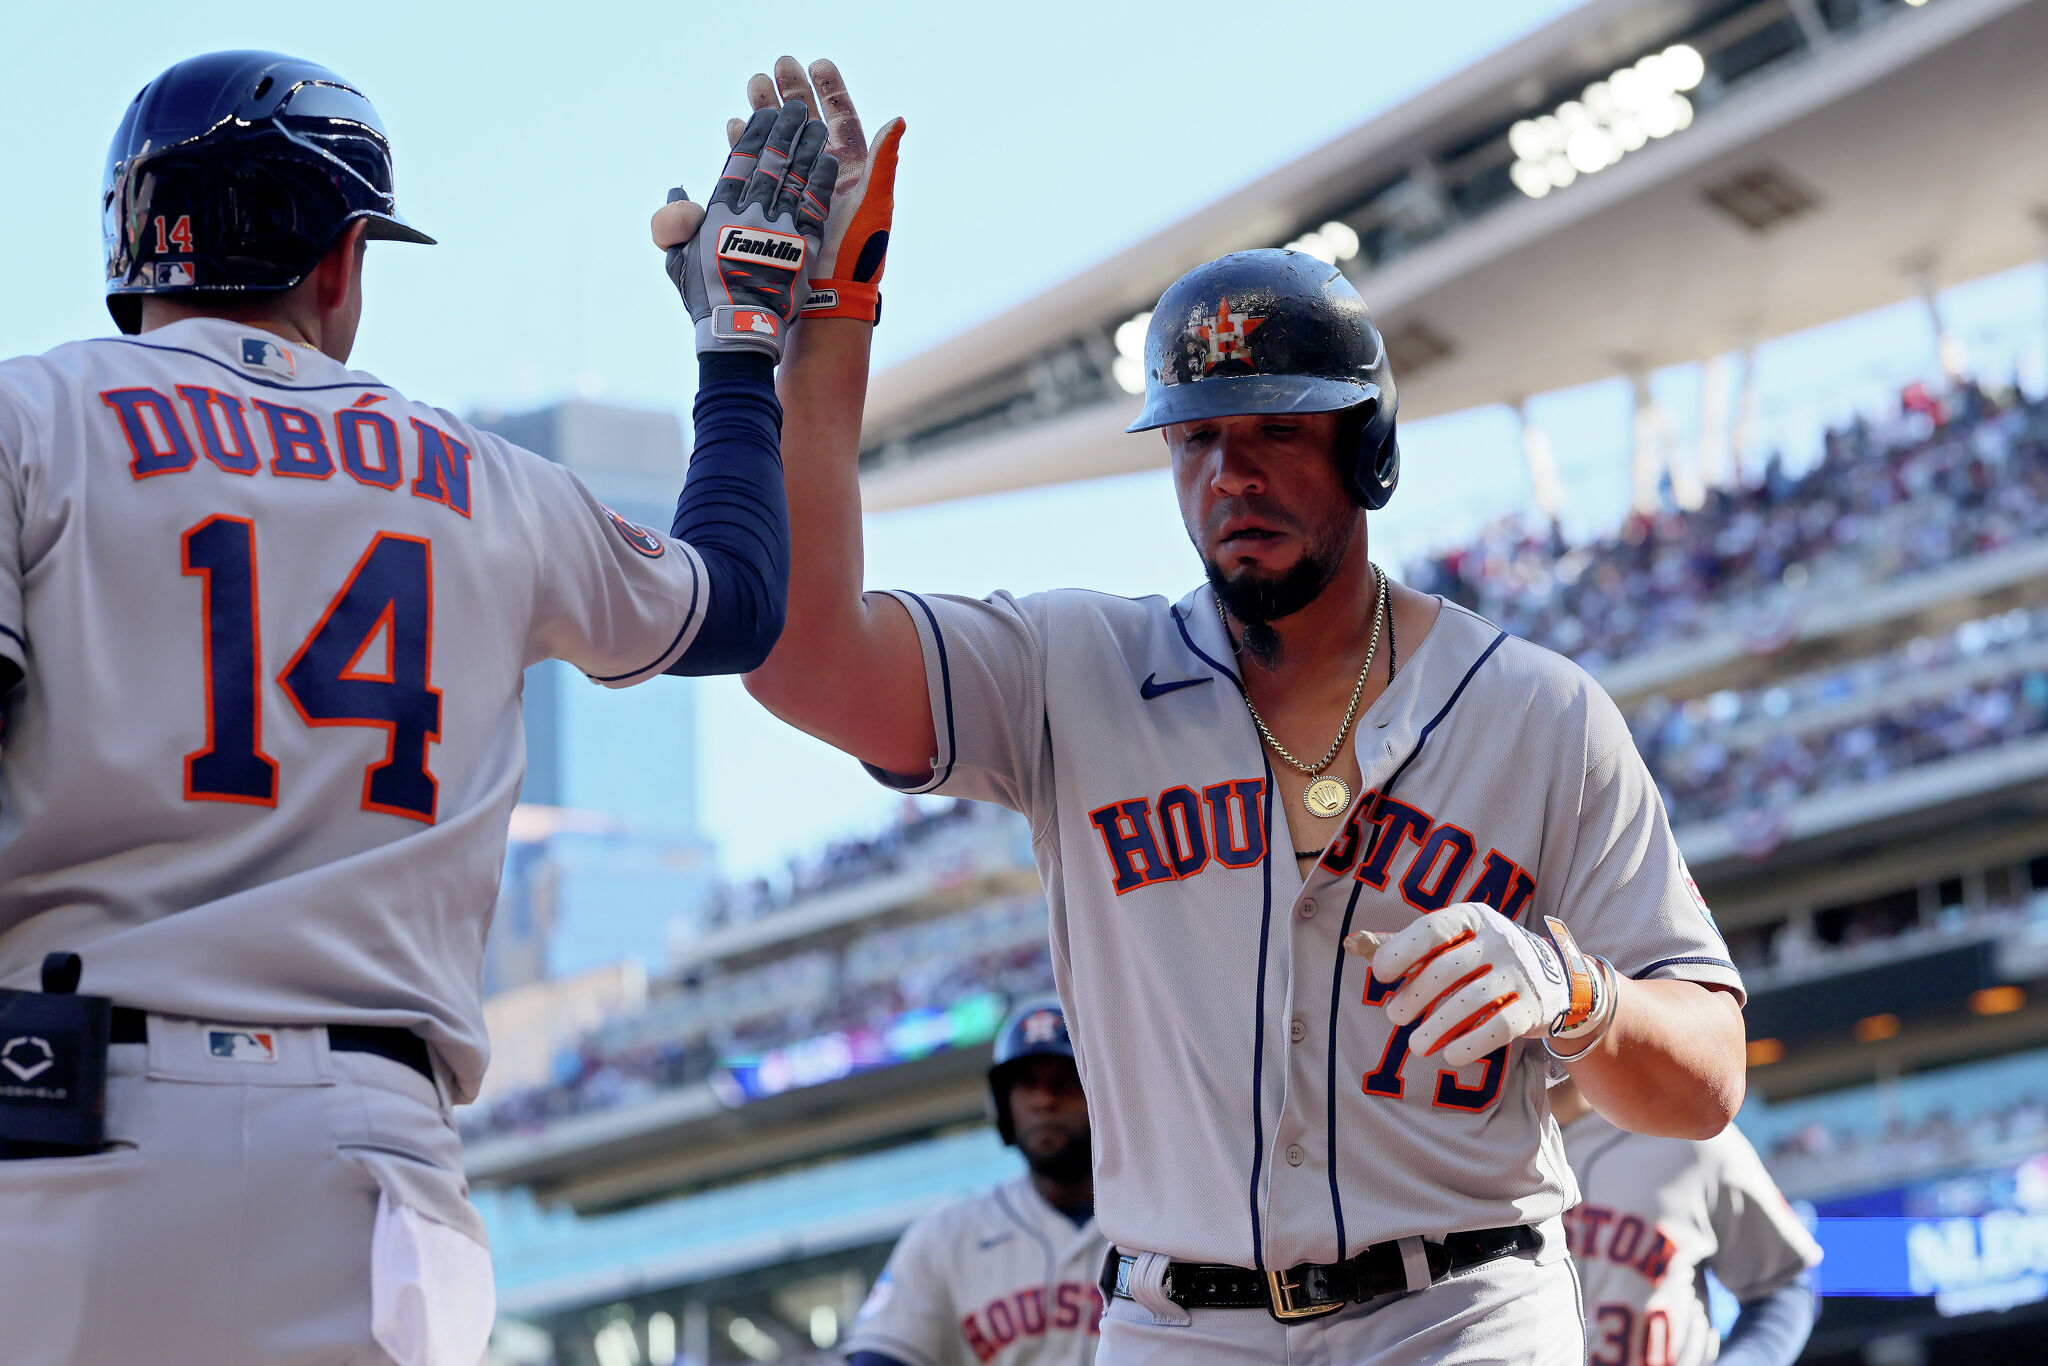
[100,51,432,334]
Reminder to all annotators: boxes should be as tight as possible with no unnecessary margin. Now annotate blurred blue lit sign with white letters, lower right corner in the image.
[1815,1155,2048,1317]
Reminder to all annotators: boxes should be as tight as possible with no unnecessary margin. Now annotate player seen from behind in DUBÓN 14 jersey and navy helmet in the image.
[0,51,836,1366]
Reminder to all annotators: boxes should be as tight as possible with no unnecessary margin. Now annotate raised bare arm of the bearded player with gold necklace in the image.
[745,319,932,772]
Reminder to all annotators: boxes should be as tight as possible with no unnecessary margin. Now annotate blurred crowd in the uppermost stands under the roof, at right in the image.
[1409,381,2048,674]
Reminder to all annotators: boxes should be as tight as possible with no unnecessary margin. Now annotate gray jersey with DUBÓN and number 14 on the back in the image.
[0,319,707,1098]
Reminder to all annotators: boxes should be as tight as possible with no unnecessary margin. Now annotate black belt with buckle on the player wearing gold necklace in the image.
[1102,1225,1542,1323]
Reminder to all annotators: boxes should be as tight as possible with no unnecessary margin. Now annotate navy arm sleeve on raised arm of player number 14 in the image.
[668,352,788,676]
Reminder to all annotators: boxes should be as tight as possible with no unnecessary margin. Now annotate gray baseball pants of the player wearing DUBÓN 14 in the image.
[0,1016,492,1366]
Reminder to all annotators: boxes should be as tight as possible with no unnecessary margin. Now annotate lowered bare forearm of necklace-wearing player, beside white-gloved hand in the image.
[1567,979,1743,1139]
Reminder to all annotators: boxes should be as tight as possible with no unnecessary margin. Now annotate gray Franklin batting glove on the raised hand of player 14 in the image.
[668,100,840,360]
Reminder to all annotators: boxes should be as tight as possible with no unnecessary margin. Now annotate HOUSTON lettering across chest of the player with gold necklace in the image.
[1087,778,1536,920]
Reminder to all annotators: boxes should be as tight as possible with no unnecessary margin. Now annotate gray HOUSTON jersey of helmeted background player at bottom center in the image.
[842,1176,1110,1366]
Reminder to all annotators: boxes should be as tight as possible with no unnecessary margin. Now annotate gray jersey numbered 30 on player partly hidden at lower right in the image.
[1565,1114,1821,1366]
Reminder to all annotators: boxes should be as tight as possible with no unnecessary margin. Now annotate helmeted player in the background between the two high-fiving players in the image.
[846,995,1108,1366]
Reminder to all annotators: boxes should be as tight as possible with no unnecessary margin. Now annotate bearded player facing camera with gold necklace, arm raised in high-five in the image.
[748,61,1743,1366]
